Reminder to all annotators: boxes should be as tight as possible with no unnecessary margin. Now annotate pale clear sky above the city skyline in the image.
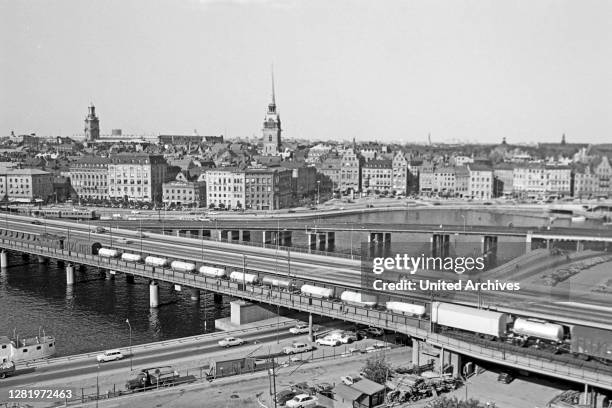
[0,0,612,143]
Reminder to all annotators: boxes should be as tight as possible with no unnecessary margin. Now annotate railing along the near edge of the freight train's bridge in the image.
[0,239,612,389]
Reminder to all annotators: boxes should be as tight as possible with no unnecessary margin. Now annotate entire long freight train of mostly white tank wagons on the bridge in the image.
[92,248,612,364]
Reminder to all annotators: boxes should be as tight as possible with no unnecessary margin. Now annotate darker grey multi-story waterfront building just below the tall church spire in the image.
[244,168,292,210]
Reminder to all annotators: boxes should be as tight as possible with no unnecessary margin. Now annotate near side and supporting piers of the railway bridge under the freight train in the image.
[0,217,612,390]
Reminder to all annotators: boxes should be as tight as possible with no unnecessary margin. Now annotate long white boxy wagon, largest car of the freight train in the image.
[431,302,508,338]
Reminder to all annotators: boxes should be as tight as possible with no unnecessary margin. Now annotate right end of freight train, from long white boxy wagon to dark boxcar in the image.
[431,302,612,365]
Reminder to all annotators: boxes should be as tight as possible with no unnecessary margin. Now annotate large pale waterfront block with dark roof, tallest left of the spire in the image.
[108,153,168,203]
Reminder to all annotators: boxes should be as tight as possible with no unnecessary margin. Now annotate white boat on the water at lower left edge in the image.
[0,334,55,363]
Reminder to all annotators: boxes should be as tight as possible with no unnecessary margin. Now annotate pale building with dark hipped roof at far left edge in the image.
[0,169,53,203]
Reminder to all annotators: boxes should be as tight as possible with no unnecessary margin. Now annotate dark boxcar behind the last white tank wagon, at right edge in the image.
[570,325,612,365]
